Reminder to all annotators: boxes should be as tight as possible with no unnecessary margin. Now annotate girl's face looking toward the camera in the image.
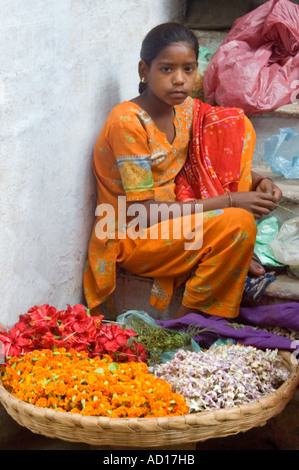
[139,42,197,106]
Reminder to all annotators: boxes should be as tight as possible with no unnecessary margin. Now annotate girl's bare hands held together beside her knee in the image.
[233,191,277,219]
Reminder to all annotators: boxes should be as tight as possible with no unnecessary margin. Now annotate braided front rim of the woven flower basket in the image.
[0,351,299,432]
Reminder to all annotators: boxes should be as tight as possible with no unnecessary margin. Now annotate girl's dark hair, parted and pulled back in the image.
[139,22,199,94]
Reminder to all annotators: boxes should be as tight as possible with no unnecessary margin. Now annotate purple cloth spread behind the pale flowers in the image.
[157,303,299,351]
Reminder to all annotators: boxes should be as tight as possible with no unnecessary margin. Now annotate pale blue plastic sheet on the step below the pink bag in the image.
[264,127,299,179]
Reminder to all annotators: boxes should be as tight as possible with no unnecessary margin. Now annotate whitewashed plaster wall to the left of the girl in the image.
[0,0,184,326]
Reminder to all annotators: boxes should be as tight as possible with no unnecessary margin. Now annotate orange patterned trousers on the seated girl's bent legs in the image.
[117,208,256,318]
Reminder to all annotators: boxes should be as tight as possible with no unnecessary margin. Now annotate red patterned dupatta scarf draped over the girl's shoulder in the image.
[176,99,244,201]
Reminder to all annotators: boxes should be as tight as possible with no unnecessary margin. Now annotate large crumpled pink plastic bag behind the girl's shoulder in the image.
[204,0,299,115]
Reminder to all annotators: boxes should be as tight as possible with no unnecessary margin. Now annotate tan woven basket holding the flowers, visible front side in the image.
[0,351,299,449]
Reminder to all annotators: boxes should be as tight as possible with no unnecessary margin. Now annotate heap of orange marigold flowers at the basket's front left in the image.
[2,348,188,418]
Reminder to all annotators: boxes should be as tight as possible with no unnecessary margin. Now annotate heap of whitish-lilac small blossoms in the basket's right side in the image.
[155,344,289,413]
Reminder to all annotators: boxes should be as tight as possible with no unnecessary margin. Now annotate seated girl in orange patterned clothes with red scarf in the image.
[84,23,281,317]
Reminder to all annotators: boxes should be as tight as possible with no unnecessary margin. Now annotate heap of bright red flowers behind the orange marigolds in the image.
[0,304,147,362]
